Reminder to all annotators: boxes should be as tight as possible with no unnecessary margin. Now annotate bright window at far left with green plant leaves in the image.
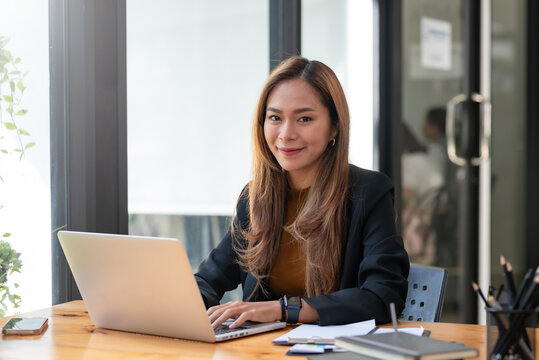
[0,0,51,314]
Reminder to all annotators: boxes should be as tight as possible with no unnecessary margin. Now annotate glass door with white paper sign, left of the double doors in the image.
[401,0,488,322]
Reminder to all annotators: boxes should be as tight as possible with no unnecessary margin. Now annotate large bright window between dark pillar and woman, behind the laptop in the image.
[127,0,269,298]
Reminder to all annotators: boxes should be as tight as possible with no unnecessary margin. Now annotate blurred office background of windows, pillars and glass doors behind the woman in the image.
[0,0,539,322]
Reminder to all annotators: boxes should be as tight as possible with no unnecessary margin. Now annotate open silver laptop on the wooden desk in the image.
[58,231,286,342]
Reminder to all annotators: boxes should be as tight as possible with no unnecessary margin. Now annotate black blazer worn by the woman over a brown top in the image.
[195,165,410,325]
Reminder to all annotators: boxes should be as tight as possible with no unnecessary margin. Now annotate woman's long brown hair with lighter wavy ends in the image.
[232,56,350,296]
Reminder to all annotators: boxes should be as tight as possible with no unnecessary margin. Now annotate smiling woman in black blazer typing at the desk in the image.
[195,57,409,328]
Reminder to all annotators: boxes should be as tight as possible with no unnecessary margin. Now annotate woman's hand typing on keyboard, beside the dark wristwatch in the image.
[208,300,281,329]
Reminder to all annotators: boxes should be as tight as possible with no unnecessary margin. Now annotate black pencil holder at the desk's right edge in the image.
[486,307,538,360]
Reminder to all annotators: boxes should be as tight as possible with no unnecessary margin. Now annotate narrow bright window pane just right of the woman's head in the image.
[301,0,373,169]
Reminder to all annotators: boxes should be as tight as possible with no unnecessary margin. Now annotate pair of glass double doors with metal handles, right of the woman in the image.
[400,0,537,322]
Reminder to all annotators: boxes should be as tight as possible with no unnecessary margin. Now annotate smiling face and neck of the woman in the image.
[264,79,337,189]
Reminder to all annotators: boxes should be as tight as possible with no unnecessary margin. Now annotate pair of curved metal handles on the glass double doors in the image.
[445,93,491,166]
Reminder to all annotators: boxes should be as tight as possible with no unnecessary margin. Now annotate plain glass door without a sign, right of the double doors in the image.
[488,0,528,312]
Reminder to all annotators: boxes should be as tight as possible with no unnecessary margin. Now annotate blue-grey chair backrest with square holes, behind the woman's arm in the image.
[399,264,447,321]
